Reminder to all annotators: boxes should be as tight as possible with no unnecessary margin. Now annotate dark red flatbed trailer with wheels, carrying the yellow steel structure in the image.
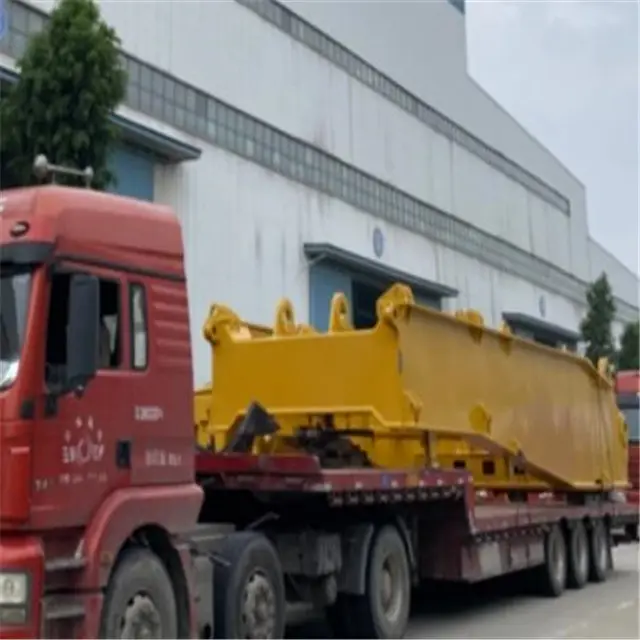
[196,453,638,638]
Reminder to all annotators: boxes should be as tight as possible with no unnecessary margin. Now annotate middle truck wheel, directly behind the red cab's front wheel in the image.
[213,531,286,639]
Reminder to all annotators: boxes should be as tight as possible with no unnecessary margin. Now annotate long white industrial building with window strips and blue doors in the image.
[0,0,638,384]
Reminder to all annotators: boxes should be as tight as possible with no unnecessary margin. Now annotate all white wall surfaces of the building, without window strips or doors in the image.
[18,1,637,358]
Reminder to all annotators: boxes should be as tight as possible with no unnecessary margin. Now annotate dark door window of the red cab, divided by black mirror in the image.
[45,273,121,386]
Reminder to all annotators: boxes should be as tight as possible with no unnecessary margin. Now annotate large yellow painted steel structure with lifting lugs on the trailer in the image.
[196,285,627,491]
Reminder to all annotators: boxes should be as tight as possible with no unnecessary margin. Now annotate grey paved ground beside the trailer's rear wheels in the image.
[289,544,640,640]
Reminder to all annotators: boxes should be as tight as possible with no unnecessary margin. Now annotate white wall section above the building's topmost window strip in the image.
[291,1,589,279]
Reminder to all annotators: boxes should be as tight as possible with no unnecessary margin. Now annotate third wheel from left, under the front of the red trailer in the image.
[349,526,411,638]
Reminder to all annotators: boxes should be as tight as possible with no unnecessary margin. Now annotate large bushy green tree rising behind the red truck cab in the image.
[0,0,127,189]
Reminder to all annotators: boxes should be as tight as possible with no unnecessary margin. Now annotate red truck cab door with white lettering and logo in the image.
[33,266,131,527]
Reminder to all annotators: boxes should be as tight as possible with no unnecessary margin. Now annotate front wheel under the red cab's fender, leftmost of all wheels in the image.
[100,547,178,638]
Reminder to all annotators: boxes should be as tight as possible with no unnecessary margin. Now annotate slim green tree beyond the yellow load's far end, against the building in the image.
[580,273,616,365]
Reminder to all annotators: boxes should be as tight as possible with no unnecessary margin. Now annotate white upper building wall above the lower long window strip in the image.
[23,0,632,296]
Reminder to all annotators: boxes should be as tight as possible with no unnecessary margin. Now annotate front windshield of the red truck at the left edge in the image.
[0,264,31,389]
